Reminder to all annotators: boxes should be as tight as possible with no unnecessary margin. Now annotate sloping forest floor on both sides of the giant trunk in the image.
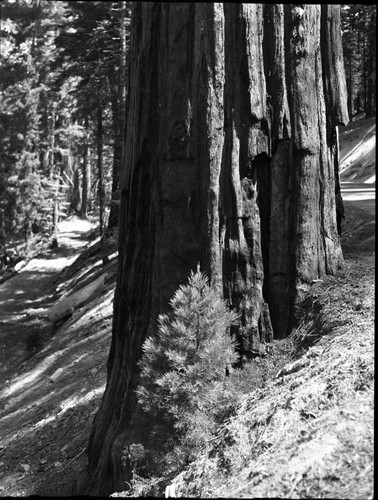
[0,116,375,499]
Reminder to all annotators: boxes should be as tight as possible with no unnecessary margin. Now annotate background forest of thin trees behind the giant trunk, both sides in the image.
[0,0,376,258]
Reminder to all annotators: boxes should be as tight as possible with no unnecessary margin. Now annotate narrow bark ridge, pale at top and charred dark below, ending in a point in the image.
[264,4,294,338]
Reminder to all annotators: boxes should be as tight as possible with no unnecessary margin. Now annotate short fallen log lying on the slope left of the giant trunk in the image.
[47,274,107,323]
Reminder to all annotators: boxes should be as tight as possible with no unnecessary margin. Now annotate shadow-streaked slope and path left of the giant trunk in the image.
[0,219,114,496]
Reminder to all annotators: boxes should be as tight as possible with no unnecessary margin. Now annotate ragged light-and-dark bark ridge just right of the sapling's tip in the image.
[221,4,271,354]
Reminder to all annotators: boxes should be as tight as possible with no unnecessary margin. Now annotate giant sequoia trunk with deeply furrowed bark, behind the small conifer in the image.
[83,2,347,494]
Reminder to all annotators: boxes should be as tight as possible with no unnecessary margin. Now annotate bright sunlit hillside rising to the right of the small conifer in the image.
[168,253,374,499]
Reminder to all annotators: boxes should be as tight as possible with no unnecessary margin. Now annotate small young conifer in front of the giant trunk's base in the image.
[137,268,238,461]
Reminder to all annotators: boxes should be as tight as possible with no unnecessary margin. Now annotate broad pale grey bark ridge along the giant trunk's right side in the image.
[285,5,341,327]
